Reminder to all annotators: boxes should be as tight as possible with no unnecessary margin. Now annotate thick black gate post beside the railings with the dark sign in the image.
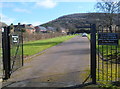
[90,24,96,84]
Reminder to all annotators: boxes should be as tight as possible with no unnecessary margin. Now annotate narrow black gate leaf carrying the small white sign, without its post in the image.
[10,32,23,72]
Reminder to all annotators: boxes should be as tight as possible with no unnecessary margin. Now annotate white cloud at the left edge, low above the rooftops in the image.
[0,13,15,25]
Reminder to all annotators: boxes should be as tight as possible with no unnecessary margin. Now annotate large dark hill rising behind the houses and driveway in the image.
[41,13,118,31]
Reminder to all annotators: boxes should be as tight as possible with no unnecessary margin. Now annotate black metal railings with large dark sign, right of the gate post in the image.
[96,25,120,83]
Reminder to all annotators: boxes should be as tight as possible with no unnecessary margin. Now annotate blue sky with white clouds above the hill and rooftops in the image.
[0,0,99,26]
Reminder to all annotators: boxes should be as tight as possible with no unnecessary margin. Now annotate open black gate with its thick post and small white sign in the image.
[2,24,23,79]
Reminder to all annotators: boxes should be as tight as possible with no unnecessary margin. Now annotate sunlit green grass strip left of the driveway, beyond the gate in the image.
[23,35,76,57]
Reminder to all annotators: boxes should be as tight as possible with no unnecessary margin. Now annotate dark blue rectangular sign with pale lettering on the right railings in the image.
[98,33,118,45]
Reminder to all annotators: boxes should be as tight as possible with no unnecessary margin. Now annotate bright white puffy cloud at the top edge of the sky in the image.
[36,0,57,8]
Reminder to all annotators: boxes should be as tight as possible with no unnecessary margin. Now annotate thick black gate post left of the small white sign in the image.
[2,27,11,79]
